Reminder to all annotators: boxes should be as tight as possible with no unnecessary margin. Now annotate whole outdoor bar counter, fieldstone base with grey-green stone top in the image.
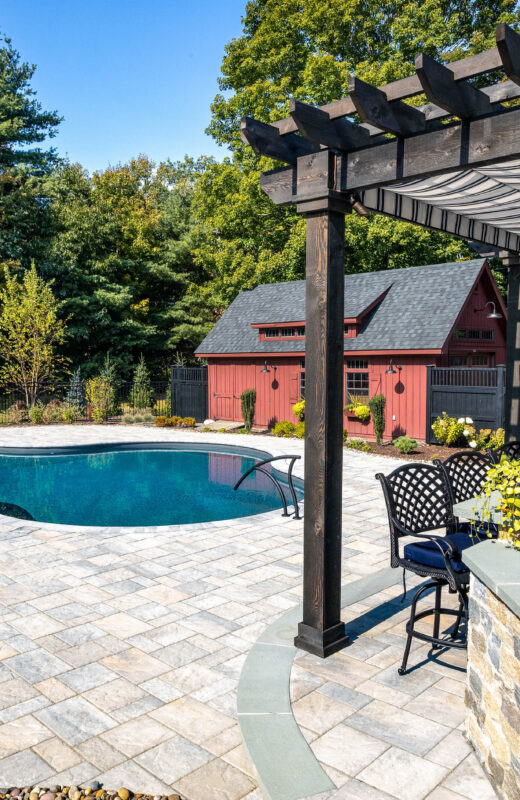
[464,541,520,800]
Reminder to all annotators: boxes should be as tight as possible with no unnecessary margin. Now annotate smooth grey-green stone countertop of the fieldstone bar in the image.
[464,539,520,617]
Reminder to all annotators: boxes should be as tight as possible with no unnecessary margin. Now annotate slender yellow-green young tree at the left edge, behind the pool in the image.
[0,265,65,407]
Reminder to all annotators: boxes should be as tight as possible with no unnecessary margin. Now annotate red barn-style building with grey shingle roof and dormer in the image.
[196,259,506,440]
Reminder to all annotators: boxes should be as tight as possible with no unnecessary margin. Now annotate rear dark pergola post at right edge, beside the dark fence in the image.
[501,253,520,442]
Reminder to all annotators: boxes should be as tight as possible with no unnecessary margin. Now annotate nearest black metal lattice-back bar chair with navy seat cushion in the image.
[376,463,484,675]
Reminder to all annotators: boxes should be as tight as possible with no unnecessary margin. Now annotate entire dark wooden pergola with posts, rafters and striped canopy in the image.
[242,24,520,657]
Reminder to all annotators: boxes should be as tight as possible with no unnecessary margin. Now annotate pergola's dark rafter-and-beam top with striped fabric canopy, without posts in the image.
[242,24,520,253]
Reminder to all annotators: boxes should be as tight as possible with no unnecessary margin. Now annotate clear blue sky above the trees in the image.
[0,0,246,171]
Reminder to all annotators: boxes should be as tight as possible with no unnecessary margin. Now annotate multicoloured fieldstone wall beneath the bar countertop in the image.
[466,575,520,800]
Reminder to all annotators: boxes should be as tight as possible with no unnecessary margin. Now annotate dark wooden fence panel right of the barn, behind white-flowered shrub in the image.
[426,367,505,444]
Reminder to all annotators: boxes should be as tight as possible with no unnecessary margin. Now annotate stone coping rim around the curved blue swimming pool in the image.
[0,439,305,535]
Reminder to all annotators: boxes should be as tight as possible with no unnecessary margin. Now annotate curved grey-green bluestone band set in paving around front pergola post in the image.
[237,567,400,800]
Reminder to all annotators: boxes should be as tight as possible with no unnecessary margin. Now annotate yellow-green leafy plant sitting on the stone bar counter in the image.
[482,455,520,550]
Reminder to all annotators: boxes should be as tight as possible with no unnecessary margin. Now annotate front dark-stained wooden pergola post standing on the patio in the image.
[295,152,350,657]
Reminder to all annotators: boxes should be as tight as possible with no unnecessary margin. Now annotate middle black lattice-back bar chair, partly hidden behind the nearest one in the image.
[433,450,498,537]
